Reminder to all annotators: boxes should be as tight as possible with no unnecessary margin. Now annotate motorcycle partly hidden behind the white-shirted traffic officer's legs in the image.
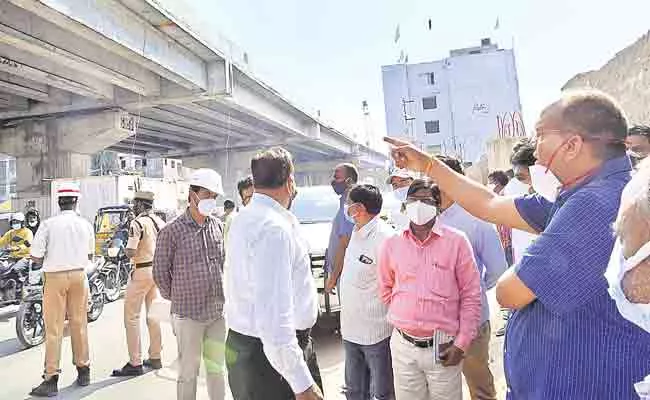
[16,262,104,348]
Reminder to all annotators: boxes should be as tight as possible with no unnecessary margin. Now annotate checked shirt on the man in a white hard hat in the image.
[153,209,224,321]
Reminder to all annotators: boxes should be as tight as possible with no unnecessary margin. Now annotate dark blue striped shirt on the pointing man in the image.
[505,157,650,400]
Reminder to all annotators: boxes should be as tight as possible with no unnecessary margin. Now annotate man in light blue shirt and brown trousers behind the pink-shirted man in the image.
[437,156,508,400]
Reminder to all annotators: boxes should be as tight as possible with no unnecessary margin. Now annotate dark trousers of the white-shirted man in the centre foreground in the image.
[226,329,323,400]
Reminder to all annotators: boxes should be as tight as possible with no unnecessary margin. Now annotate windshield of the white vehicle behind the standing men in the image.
[291,186,339,224]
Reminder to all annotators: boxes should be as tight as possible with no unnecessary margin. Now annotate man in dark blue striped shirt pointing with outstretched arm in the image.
[387,91,650,400]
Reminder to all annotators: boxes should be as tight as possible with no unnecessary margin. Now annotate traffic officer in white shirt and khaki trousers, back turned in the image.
[30,184,95,397]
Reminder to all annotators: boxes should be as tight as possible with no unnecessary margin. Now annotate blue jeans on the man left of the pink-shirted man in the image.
[343,338,395,400]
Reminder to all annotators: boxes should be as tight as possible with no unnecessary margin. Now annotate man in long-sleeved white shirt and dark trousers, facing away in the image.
[225,148,323,400]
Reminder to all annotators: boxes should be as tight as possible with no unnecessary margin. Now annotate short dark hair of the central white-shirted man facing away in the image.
[251,147,293,189]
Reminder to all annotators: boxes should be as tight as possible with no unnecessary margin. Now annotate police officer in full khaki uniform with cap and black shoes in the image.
[113,192,165,376]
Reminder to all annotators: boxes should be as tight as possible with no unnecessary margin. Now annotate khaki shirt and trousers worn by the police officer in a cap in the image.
[124,212,165,366]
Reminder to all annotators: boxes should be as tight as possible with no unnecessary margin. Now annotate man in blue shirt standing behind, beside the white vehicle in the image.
[325,163,359,293]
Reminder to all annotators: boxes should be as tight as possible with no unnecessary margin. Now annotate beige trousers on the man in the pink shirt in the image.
[390,330,463,400]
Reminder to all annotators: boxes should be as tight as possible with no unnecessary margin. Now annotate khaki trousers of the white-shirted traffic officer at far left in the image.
[43,270,90,378]
